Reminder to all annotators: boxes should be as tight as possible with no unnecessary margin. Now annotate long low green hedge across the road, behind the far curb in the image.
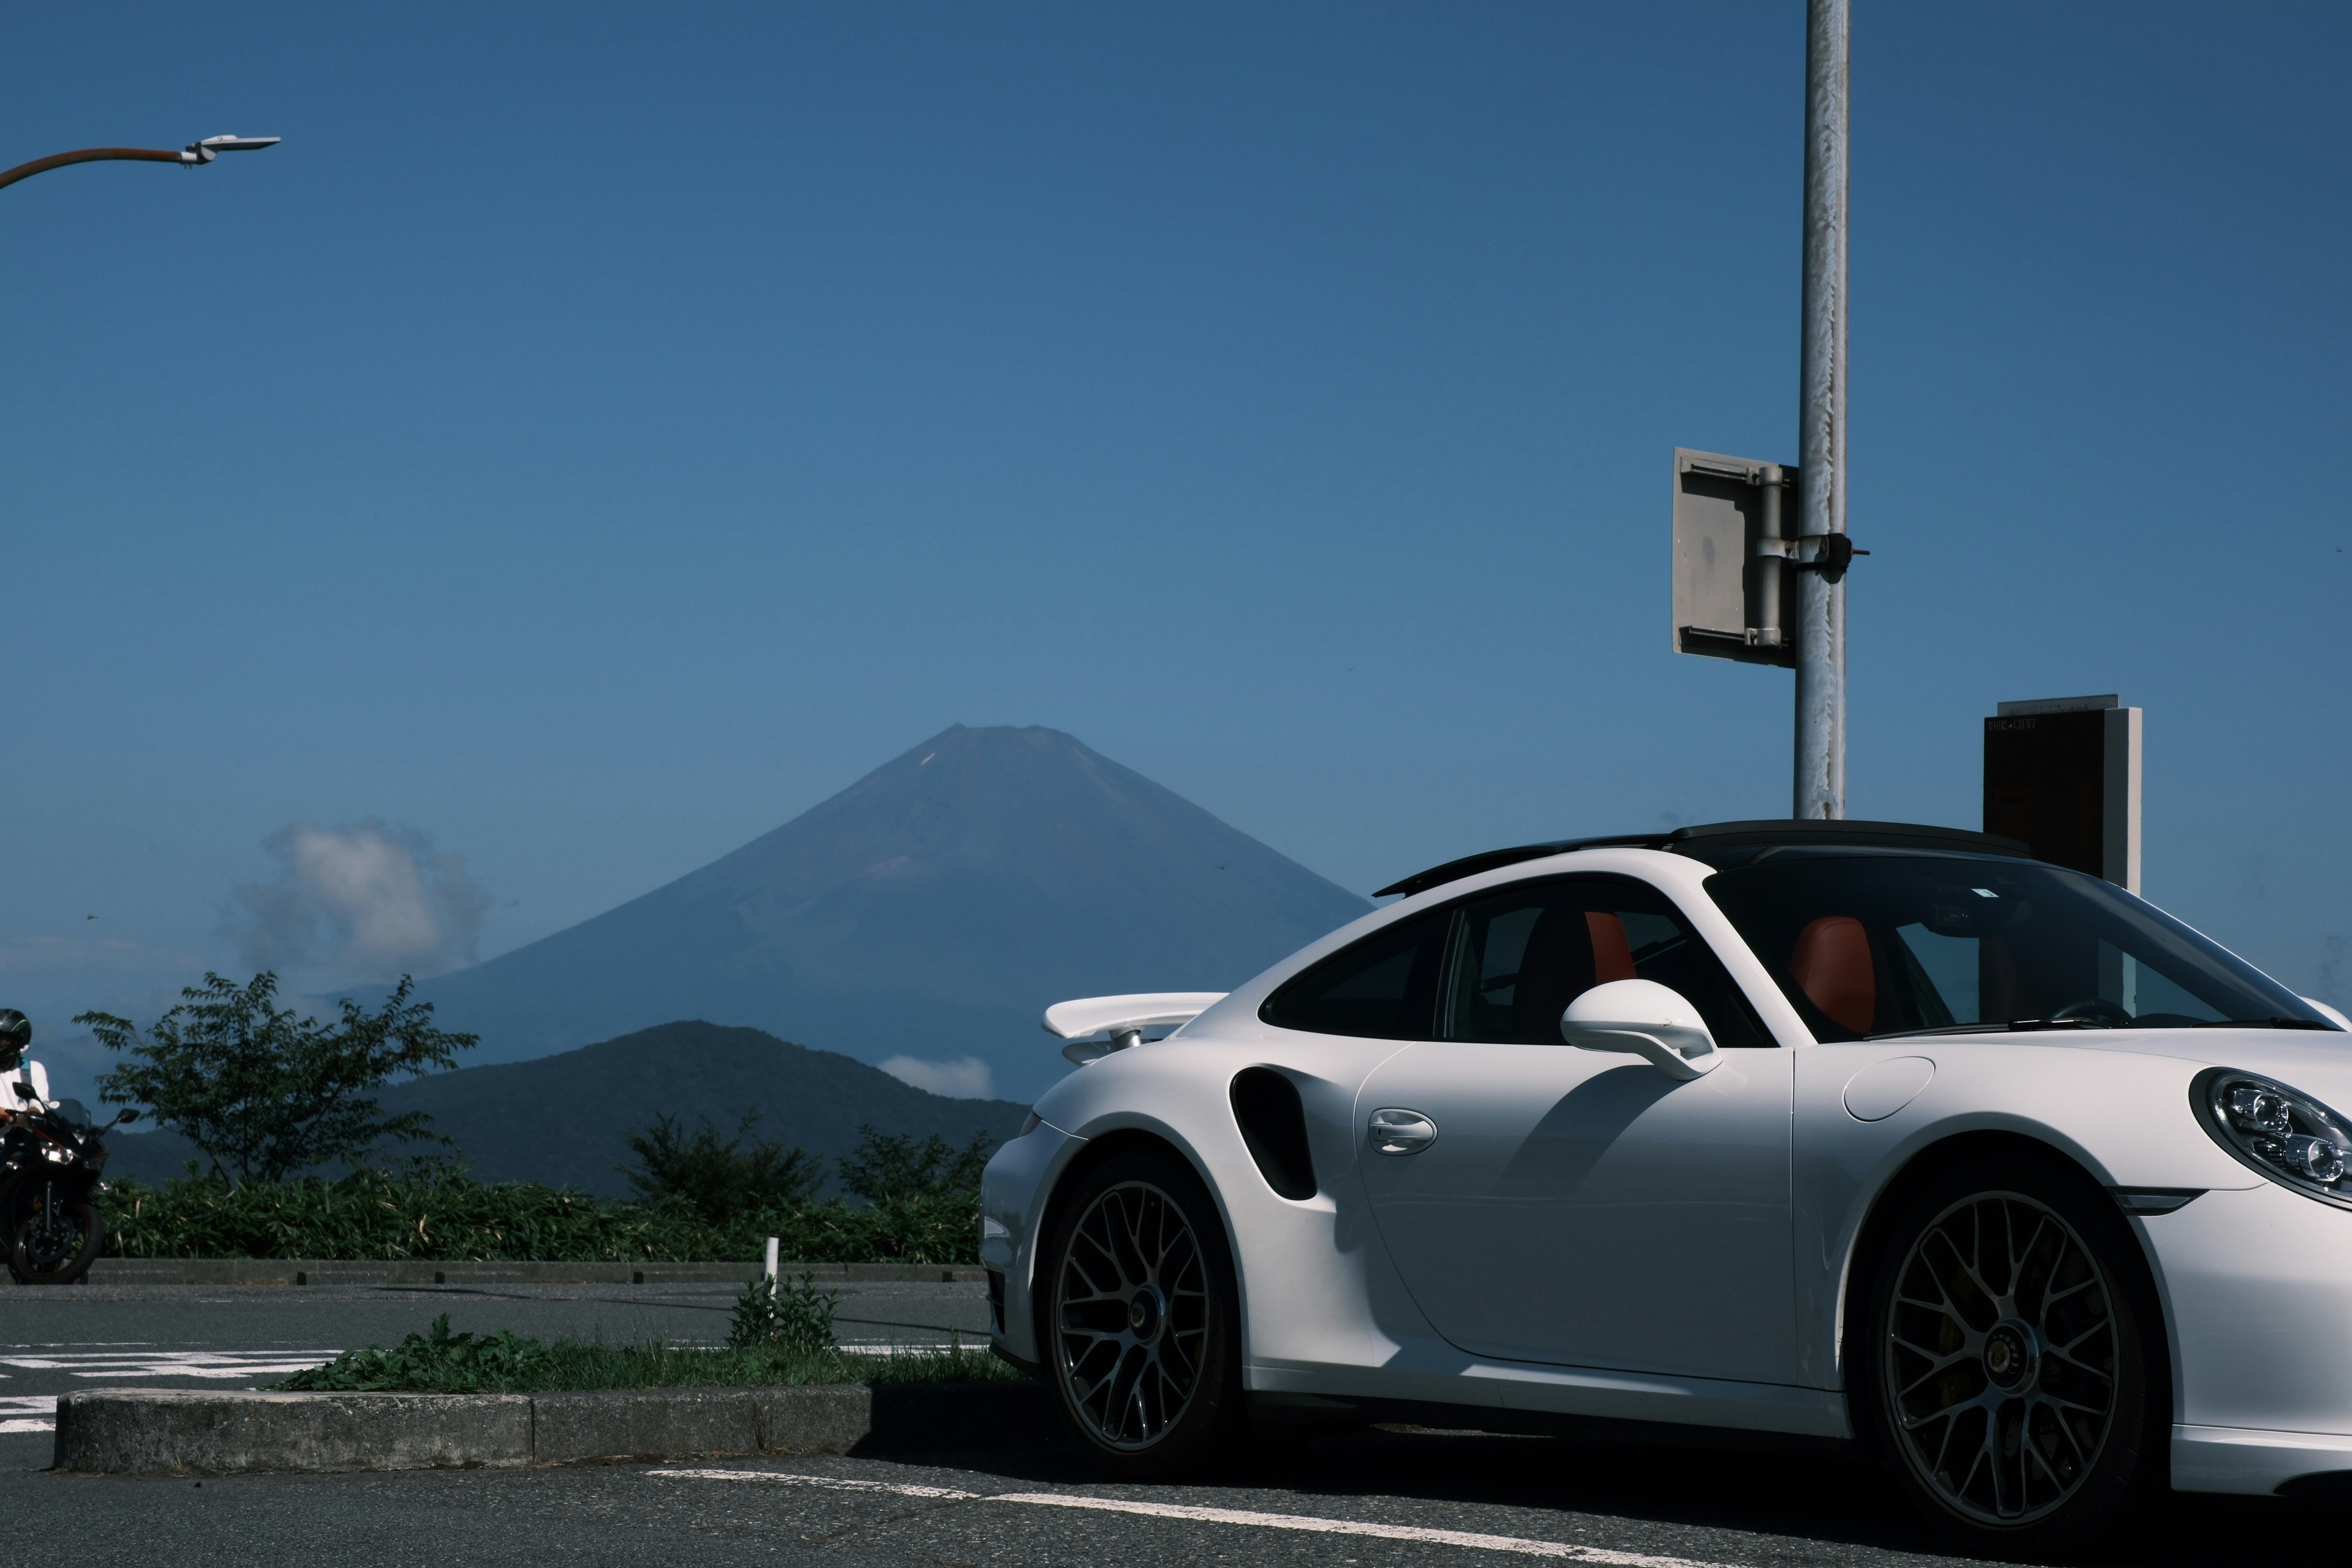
[104,1170,981,1262]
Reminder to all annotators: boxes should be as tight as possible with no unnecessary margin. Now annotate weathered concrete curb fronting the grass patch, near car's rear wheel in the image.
[54,1382,1051,1476]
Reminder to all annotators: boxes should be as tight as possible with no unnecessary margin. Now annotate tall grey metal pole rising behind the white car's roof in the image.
[1792,0,1851,818]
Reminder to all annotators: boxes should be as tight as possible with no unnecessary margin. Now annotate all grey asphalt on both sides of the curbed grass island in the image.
[0,1286,2347,1568]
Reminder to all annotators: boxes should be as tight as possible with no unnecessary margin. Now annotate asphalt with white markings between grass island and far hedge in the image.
[0,1281,988,1436]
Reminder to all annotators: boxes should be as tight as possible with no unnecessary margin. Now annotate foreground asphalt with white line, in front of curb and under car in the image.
[0,1431,2340,1568]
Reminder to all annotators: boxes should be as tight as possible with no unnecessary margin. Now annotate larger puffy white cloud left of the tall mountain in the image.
[226,818,489,980]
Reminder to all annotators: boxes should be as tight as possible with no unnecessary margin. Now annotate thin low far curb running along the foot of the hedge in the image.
[75,1257,988,1286]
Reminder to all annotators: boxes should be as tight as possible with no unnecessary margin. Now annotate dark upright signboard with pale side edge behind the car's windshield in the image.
[1985,696,2140,893]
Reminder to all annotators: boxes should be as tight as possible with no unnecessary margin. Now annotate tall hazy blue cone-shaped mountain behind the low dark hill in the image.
[399,724,1371,1096]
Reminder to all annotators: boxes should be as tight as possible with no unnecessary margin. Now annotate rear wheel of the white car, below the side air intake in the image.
[1037,1150,1244,1479]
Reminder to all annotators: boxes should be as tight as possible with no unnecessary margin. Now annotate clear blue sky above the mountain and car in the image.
[0,0,2352,1086]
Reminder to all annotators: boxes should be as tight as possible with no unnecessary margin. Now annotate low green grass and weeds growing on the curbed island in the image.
[275,1312,1021,1394]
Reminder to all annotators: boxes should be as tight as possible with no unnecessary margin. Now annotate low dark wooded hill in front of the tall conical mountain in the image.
[108,1023,1028,1197]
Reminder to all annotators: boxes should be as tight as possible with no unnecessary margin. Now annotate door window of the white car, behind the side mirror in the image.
[1444,877,1773,1046]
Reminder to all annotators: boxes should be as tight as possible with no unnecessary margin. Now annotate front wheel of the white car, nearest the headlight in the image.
[1846,1154,2171,1559]
